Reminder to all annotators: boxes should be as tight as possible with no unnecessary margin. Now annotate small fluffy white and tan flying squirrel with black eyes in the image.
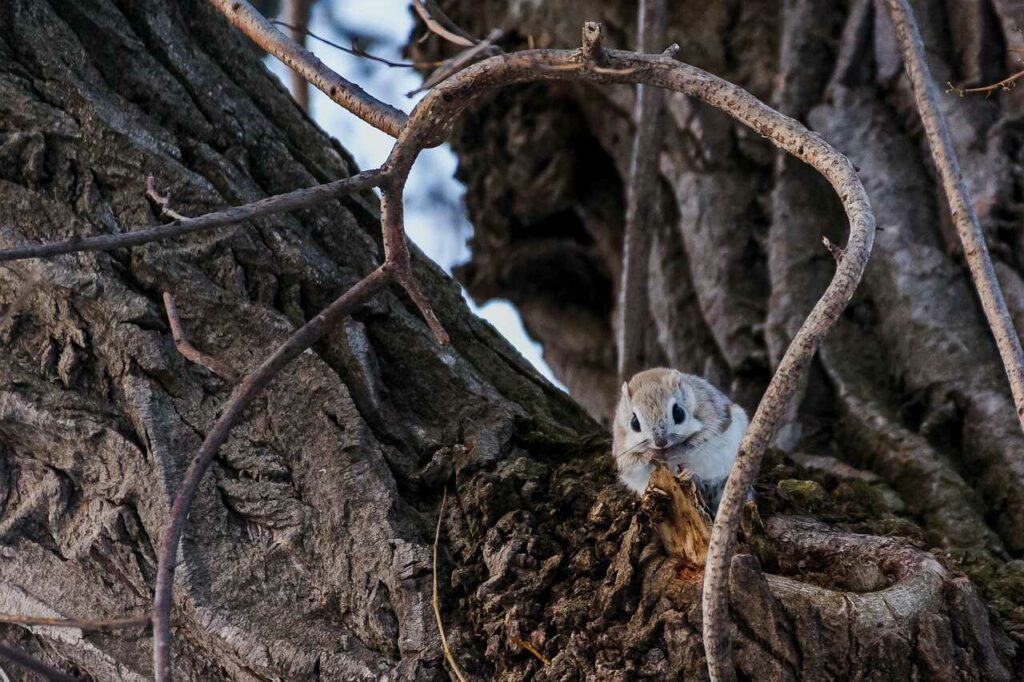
[612,368,748,515]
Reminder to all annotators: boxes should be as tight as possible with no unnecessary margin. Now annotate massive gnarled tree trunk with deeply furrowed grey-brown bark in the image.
[0,0,1024,680]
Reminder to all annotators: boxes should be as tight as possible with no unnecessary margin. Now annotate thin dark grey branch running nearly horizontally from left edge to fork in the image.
[0,170,384,262]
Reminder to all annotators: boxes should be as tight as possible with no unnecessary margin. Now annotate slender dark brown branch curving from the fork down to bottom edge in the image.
[153,264,391,682]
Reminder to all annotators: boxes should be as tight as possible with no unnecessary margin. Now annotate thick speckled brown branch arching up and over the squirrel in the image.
[387,34,874,680]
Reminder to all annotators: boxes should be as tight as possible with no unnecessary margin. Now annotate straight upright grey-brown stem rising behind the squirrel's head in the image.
[617,0,668,381]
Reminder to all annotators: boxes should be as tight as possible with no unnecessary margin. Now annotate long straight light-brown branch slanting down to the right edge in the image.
[886,0,1024,428]
